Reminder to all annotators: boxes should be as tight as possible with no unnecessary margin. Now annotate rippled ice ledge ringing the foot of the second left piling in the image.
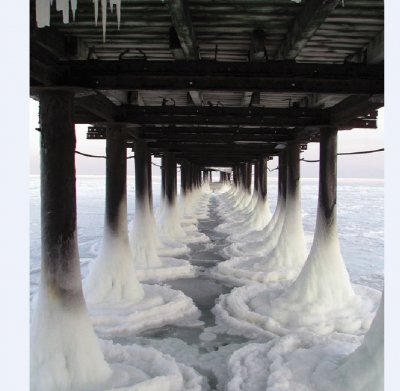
[88,284,203,338]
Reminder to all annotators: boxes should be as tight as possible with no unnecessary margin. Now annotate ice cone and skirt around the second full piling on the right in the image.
[213,177,306,285]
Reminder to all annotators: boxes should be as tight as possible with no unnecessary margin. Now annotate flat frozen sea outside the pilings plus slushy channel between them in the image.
[30,176,384,390]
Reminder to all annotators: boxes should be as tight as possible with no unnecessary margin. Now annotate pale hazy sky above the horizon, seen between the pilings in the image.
[29,99,384,178]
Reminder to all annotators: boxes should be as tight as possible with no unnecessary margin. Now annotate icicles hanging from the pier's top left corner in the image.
[36,0,121,41]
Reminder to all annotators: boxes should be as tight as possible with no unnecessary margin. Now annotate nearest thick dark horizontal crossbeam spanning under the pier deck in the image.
[60,60,384,94]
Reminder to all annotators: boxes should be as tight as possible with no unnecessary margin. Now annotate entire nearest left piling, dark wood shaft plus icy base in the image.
[30,90,111,391]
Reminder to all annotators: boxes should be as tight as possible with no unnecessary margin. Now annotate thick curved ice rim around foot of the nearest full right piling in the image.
[212,283,381,338]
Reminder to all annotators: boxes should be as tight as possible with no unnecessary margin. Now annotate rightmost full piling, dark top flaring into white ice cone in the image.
[287,127,354,313]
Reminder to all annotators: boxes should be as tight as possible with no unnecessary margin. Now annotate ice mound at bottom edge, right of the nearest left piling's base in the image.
[99,341,209,391]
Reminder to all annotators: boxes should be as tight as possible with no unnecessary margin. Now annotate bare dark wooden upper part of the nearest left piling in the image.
[39,90,84,306]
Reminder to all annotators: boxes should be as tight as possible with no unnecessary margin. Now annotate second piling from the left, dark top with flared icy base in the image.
[84,124,144,304]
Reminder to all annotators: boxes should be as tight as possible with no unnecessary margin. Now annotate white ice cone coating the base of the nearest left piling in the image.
[30,250,111,391]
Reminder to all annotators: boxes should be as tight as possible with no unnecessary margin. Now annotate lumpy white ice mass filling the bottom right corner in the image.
[226,299,384,391]
